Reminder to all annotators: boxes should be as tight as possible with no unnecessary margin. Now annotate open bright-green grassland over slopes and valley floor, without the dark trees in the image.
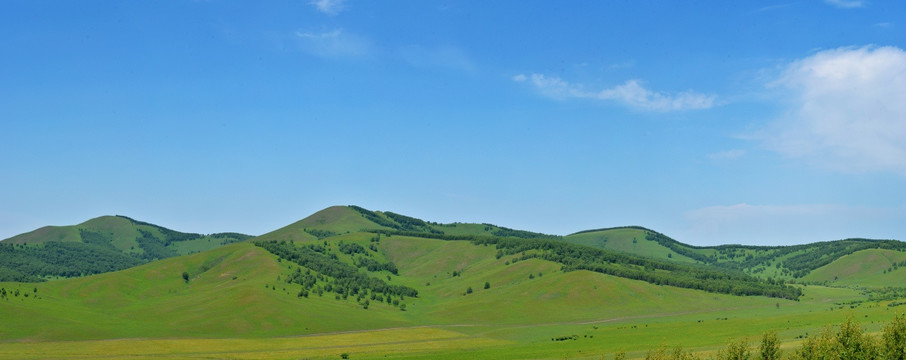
[0,207,906,359]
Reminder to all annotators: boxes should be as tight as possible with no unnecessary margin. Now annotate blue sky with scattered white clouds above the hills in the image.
[0,0,906,245]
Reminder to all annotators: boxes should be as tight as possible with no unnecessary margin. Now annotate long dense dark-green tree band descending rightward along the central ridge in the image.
[472,238,802,300]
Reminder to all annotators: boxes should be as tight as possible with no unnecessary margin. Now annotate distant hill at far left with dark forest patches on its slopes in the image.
[0,216,250,281]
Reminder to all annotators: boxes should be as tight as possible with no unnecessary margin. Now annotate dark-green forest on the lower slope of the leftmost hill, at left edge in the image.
[0,241,143,282]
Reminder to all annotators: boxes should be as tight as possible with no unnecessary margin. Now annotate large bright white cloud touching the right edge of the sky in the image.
[757,47,906,176]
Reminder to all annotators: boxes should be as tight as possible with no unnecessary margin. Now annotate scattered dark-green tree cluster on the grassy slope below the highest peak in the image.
[249,241,418,298]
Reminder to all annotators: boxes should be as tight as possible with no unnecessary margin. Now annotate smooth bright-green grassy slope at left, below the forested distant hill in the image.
[0,243,409,340]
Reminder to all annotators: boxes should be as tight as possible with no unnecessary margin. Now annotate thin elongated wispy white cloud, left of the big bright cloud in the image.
[513,74,716,111]
